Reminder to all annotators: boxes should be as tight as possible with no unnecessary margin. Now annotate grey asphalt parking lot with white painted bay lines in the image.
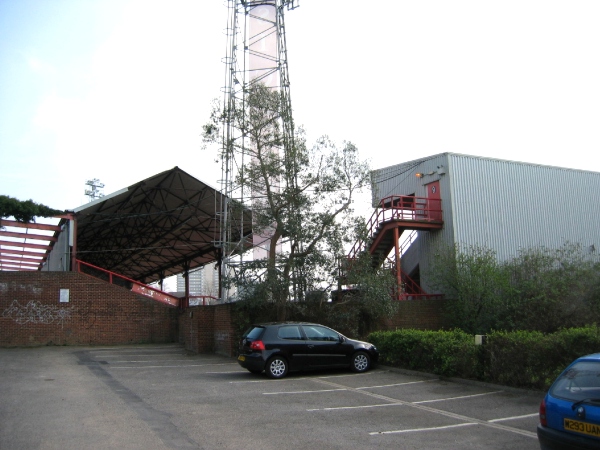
[0,345,542,450]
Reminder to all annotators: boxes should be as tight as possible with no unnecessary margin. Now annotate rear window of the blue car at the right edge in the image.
[550,361,600,401]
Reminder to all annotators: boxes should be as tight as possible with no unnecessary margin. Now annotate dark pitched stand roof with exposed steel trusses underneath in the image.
[75,167,252,283]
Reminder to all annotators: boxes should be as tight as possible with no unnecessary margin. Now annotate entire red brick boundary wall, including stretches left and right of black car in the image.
[0,272,446,356]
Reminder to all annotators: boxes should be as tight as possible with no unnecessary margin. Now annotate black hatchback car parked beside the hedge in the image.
[238,322,379,378]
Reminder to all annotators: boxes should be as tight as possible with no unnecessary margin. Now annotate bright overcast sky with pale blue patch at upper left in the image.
[0,0,600,214]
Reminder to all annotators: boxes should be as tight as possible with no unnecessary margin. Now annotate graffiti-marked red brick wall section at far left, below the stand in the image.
[0,272,179,347]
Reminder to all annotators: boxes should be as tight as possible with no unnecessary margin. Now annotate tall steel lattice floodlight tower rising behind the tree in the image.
[219,0,298,300]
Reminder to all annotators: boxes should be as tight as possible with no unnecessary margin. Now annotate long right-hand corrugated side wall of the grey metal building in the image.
[444,154,600,260]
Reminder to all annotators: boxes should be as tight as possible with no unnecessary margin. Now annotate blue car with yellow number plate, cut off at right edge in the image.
[537,353,600,450]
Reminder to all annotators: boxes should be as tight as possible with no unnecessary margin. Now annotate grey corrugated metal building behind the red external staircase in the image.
[373,153,600,294]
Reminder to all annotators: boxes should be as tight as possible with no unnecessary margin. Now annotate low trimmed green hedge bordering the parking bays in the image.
[368,326,600,390]
